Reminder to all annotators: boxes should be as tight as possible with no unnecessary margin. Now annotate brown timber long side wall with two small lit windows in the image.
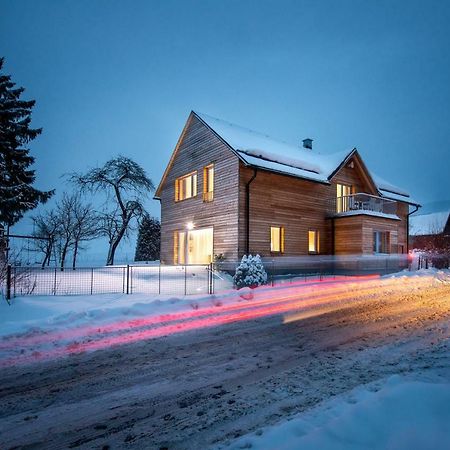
[239,164,335,257]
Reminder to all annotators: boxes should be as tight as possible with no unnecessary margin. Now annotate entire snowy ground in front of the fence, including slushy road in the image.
[0,271,450,449]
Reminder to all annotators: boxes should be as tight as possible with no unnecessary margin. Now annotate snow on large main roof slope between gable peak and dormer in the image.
[195,112,350,182]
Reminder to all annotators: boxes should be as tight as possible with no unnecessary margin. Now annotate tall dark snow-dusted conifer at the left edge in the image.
[0,58,53,225]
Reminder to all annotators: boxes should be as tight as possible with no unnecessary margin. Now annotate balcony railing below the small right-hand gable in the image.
[329,193,397,215]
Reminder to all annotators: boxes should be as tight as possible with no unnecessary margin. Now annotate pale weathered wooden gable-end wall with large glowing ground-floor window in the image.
[160,115,239,264]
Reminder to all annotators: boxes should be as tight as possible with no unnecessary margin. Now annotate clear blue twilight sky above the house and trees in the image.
[0,0,450,258]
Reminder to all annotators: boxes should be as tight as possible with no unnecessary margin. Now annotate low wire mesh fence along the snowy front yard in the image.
[6,255,420,298]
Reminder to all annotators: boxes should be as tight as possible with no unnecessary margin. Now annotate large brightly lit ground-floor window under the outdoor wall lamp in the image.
[174,227,214,264]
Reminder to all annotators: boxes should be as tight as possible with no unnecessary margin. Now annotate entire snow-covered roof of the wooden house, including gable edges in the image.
[156,111,417,205]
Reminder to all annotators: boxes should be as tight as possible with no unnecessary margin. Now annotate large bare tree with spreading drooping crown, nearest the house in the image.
[71,156,154,265]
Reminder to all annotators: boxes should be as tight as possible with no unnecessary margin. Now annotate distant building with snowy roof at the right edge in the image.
[409,211,450,250]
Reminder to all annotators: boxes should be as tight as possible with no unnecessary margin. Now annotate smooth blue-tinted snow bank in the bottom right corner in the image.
[231,375,450,450]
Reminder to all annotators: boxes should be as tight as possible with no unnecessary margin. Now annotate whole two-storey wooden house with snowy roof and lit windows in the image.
[155,112,418,264]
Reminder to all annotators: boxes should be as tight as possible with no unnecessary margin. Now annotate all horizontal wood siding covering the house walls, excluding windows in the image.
[160,118,408,264]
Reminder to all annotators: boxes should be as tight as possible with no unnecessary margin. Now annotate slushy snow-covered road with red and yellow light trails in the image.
[0,276,450,449]
